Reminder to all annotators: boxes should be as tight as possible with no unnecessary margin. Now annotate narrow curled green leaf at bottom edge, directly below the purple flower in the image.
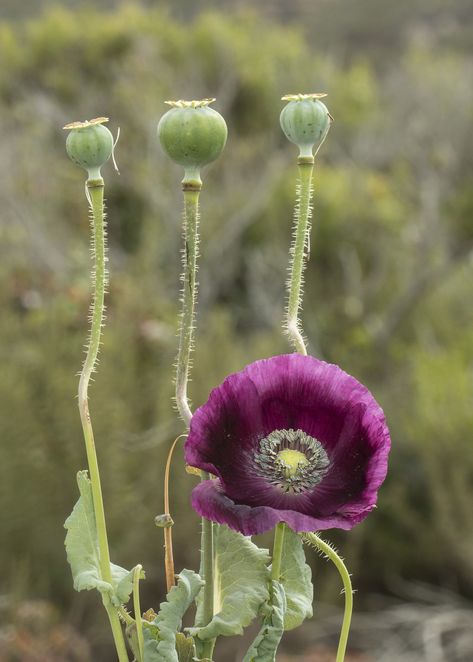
[243,581,286,662]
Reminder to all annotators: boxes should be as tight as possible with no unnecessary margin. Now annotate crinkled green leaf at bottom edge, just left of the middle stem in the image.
[143,570,204,662]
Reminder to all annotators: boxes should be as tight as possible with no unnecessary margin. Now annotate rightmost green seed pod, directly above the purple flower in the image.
[279,93,332,161]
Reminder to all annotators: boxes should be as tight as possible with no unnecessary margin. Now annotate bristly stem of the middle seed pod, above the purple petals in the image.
[176,181,200,427]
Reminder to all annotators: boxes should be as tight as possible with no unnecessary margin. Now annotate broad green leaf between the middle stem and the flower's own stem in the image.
[189,526,269,640]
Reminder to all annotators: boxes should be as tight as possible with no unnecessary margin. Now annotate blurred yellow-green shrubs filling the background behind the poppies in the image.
[0,5,473,659]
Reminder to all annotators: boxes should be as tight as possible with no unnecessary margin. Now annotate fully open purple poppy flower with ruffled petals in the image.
[185,354,391,535]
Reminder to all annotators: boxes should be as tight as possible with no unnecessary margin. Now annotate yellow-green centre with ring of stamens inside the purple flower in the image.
[254,429,330,494]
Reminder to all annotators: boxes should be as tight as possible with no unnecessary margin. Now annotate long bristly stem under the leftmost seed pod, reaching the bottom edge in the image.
[78,178,128,662]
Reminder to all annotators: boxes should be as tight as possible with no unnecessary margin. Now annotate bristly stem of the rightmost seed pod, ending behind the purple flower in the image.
[285,157,314,355]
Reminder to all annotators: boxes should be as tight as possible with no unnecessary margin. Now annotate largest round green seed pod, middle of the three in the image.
[158,99,227,187]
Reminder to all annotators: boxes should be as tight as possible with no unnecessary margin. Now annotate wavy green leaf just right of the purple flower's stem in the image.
[279,526,314,630]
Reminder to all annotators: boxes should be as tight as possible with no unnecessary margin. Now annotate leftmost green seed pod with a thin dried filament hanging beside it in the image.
[64,117,114,179]
